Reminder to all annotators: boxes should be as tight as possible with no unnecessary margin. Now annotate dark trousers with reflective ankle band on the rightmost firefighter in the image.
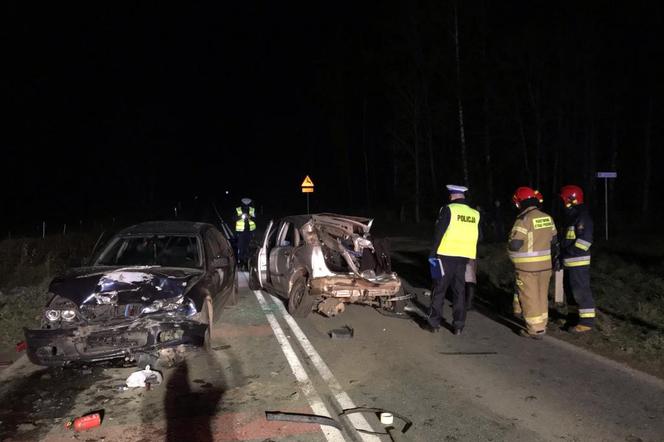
[563,266,595,327]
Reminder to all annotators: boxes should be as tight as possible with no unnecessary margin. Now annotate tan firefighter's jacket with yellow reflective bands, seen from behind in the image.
[507,206,558,272]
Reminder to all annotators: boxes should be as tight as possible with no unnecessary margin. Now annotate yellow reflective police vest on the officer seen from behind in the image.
[436,203,480,259]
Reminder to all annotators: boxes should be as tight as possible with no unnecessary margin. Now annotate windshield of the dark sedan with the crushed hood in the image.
[95,235,203,268]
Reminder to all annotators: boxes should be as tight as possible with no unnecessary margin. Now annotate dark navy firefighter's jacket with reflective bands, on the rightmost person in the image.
[560,204,593,268]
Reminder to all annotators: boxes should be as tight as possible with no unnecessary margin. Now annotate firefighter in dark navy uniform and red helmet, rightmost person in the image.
[560,185,595,333]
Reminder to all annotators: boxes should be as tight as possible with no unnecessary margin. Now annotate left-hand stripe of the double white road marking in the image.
[254,290,345,442]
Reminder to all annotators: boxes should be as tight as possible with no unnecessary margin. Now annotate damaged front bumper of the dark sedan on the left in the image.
[24,317,208,366]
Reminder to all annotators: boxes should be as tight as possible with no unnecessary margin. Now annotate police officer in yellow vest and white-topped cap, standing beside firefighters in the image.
[424,184,480,335]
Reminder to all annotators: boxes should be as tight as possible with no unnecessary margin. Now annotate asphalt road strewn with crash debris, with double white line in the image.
[0,275,664,442]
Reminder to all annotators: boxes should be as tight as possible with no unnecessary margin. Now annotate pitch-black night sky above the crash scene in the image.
[5,1,664,237]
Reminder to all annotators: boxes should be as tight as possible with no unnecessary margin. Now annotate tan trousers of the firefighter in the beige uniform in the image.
[516,270,551,334]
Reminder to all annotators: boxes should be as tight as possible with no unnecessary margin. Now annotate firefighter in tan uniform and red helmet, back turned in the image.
[507,187,558,339]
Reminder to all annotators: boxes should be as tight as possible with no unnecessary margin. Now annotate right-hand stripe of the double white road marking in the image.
[270,295,380,442]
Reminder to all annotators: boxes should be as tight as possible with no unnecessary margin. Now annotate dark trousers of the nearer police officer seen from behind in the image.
[427,255,468,329]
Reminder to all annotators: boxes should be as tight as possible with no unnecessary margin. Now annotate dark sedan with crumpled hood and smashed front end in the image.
[25,221,237,366]
